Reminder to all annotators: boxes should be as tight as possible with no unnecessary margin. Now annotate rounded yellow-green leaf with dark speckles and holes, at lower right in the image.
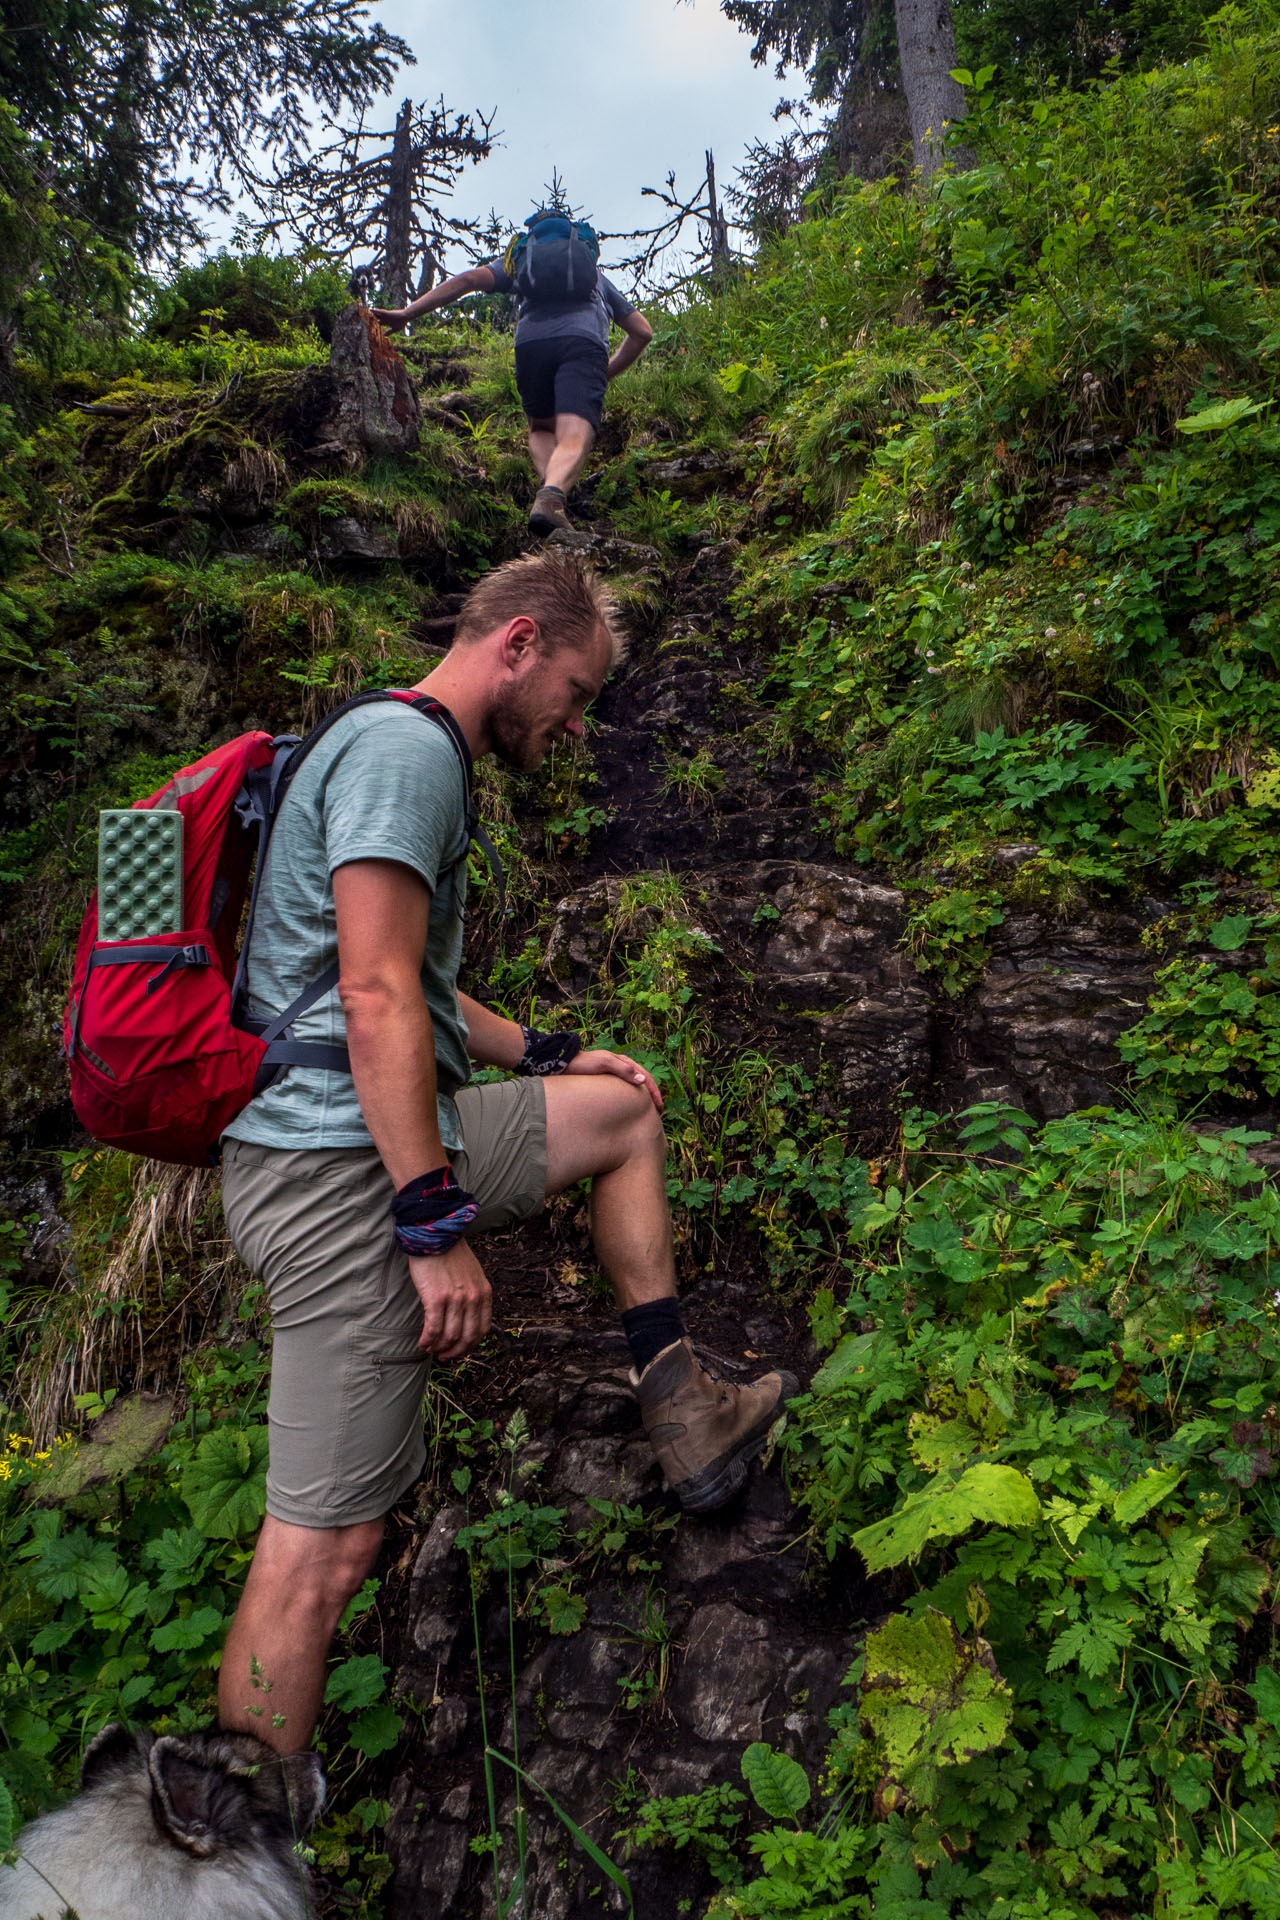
[862,1607,1013,1807]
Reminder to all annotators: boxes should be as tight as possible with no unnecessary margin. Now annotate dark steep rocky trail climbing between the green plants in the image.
[343,453,1189,1920]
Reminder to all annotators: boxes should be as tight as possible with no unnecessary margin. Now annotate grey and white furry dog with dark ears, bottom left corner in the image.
[0,1726,324,1920]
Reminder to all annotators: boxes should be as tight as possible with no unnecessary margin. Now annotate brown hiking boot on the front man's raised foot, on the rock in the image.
[631,1340,798,1513]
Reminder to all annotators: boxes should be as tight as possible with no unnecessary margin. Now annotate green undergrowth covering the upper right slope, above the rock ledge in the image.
[637,4,1280,1085]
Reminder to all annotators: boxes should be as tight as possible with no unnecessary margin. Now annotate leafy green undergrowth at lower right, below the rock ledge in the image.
[624,1106,1280,1920]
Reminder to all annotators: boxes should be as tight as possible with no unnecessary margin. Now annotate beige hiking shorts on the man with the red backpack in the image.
[223,1079,547,1526]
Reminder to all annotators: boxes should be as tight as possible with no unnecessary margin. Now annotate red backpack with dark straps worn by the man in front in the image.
[63,691,501,1167]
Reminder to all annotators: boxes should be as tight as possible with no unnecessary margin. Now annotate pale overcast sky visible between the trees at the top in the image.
[364,0,785,271]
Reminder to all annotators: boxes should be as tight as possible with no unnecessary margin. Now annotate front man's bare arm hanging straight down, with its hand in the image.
[334,860,491,1359]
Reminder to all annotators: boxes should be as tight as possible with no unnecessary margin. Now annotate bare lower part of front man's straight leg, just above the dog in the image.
[219,1515,384,1753]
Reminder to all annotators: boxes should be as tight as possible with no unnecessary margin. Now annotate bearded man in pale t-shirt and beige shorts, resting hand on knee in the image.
[208,555,796,1753]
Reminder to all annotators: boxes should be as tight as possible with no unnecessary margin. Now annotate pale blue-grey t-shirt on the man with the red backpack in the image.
[226,703,470,1148]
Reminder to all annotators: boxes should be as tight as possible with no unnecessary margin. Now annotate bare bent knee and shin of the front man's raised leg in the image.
[547,1075,676,1311]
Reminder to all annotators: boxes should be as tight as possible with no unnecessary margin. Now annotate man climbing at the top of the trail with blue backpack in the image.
[374,207,652,534]
